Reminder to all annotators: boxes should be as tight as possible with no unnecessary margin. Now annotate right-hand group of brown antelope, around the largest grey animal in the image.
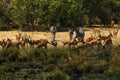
[63,28,120,48]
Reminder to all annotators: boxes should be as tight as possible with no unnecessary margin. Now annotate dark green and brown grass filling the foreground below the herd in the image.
[0,46,120,80]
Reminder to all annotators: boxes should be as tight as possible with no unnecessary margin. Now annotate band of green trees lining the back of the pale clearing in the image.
[0,0,120,30]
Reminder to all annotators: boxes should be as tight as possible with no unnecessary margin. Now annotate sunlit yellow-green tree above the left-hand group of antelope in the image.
[11,0,42,30]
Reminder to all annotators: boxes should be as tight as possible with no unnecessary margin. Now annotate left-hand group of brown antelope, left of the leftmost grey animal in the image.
[0,33,57,49]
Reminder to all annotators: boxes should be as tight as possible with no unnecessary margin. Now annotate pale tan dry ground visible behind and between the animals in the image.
[0,29,120,45]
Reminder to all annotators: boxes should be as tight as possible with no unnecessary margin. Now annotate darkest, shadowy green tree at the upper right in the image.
[84,0,120,26]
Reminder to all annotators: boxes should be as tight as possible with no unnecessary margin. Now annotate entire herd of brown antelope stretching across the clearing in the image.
[0,28,119,49]
